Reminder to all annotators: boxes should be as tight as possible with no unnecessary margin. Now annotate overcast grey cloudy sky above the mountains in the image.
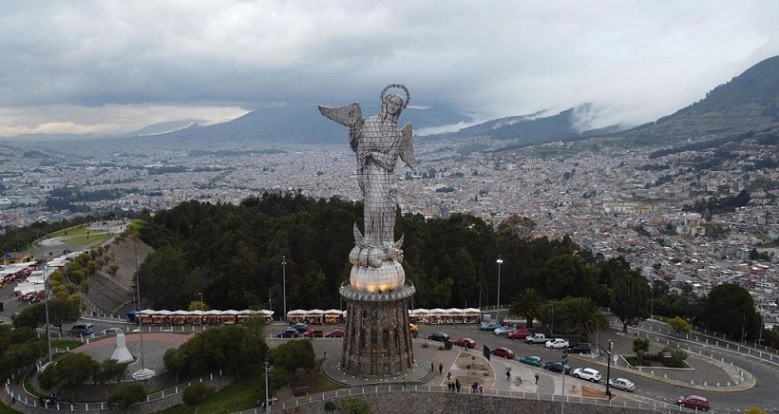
[0,0,779,136]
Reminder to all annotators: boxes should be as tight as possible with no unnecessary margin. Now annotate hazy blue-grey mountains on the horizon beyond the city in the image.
[3,56,779,148]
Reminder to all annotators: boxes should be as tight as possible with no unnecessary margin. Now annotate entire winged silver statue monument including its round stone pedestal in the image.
[319,84,416,377]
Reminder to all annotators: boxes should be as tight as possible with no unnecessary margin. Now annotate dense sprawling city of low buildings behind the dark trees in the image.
[0,132,779,328]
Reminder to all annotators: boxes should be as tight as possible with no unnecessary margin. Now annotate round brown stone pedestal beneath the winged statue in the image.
[340,284,415,378]
